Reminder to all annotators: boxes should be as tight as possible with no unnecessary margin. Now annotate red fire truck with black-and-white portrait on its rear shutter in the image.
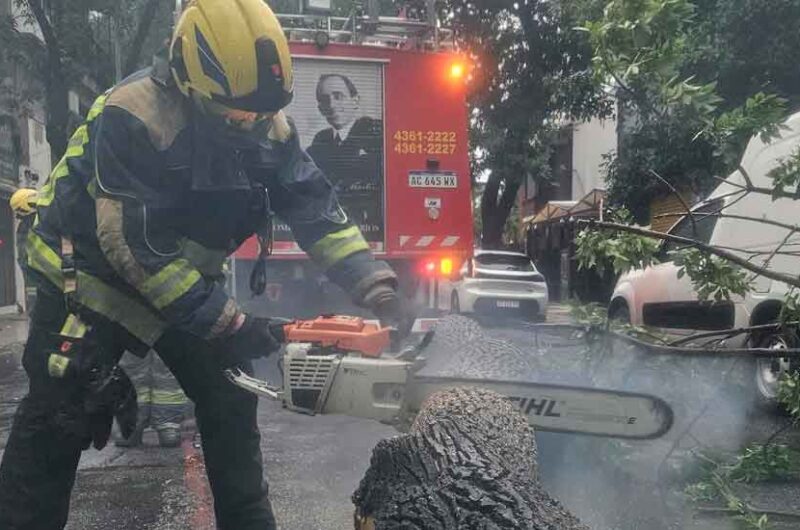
[230,2,473,317]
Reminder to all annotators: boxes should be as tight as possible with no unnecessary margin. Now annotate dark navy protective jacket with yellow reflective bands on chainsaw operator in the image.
[28,63,396,346]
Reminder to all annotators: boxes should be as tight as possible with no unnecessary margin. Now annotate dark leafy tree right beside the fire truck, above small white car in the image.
[445,0,609,247]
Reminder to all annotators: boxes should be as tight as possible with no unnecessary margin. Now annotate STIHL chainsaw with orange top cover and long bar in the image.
[225,316,673,440]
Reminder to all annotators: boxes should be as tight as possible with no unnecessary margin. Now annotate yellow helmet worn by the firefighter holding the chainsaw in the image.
[170,0,293,113]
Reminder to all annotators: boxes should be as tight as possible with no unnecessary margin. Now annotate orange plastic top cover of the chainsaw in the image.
[283,315,391,357]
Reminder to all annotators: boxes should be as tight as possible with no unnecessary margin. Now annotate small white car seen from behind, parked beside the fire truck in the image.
[440,250,548,320]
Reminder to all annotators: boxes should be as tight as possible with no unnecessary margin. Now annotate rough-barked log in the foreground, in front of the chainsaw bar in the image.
[353,388,588,530]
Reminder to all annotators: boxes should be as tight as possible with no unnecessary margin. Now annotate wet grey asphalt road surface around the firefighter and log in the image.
[0,316,800,530]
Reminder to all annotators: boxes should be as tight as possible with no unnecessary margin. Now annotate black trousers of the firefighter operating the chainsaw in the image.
[0,289,275,530]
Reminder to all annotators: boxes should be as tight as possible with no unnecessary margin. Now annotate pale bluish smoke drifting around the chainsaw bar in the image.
[423,317,753,530]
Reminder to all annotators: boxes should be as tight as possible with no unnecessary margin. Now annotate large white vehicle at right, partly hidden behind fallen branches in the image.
[609,113,800,403]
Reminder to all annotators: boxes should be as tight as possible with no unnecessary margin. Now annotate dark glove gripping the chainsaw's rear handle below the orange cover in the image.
[218,315,286,368]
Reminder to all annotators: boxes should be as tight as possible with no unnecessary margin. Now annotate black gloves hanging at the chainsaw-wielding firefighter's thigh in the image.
[84,366,138,450]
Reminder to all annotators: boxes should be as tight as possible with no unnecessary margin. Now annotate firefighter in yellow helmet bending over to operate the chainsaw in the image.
[0,0,411,530]
